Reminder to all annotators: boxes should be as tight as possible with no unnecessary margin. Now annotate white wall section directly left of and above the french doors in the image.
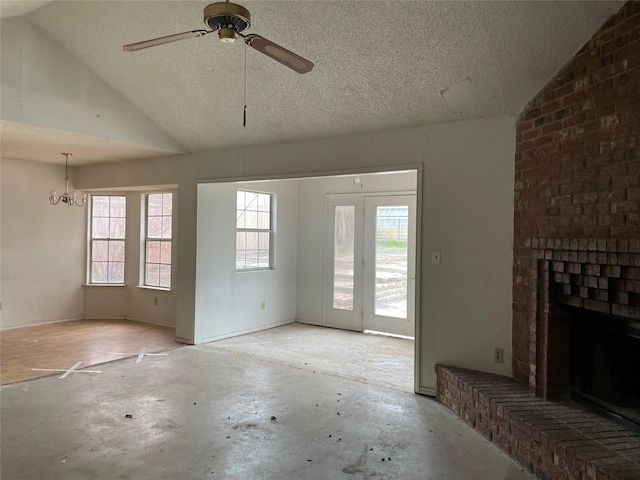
[296,171,418,325]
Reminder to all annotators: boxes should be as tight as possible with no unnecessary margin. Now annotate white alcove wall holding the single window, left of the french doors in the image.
[195,180,298,343]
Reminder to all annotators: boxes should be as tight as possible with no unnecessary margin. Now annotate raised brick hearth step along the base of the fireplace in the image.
[436,365,640,480]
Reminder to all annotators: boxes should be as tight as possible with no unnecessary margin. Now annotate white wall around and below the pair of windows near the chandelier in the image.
[84,188,178,326]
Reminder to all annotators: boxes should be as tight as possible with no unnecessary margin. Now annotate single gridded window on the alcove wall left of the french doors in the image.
[235,189,276,272]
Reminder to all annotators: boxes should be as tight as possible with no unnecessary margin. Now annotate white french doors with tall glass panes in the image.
[324,195,416,337]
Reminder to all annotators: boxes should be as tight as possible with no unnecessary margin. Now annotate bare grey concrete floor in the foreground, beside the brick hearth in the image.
[0,324,533,480]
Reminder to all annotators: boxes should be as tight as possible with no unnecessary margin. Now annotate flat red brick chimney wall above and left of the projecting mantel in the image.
[513,1,640,384]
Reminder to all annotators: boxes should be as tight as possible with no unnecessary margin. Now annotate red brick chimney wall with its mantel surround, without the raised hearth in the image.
[512,2,640,397]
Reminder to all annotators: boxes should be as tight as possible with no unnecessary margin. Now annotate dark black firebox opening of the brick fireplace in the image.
[570,308,640,431]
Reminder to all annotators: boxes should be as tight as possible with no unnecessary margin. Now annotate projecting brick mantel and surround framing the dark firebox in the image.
[525,238,640,408]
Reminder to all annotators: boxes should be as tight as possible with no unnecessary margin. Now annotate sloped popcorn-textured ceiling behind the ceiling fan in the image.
[2,0,623,165]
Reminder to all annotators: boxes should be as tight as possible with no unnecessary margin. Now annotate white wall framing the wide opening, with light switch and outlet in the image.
[78,117,515,393]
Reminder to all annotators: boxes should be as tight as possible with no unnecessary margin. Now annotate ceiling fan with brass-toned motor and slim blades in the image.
[122,0,313,73]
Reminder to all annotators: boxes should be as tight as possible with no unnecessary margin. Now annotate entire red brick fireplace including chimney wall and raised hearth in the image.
[436,1,640,480]
